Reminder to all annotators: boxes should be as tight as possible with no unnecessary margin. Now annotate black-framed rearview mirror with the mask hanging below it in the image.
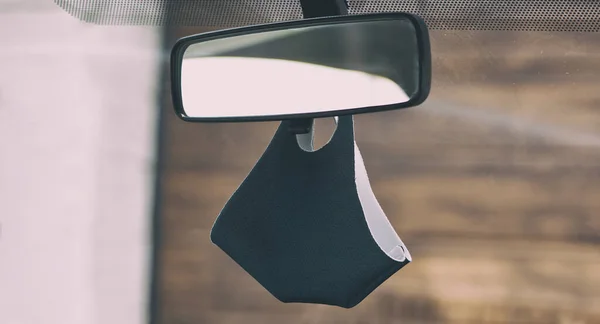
[171,13,431,122]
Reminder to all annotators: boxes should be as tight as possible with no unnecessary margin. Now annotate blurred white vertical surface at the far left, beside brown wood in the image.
[0,1,160,324]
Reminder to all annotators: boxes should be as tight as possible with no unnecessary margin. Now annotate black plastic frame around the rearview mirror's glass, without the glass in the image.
[171,12,431,123]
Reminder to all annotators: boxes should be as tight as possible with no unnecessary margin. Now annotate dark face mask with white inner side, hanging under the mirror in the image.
[211,116,411,308]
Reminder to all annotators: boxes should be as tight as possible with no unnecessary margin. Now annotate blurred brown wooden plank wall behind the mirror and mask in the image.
[157,29,600,324]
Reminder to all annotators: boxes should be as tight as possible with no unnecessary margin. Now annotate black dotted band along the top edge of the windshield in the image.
[55,0,600,32]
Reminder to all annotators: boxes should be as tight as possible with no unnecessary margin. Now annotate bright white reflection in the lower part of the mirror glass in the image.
[181,56,410,118]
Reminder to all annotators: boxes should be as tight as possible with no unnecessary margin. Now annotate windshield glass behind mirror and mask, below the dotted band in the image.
[0,1,600,324]
